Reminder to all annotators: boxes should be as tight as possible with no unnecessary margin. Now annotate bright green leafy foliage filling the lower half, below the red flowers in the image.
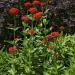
[0,35,75,75]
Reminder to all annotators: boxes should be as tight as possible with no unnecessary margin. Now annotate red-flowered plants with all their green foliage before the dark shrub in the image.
[0,0,75,75]
